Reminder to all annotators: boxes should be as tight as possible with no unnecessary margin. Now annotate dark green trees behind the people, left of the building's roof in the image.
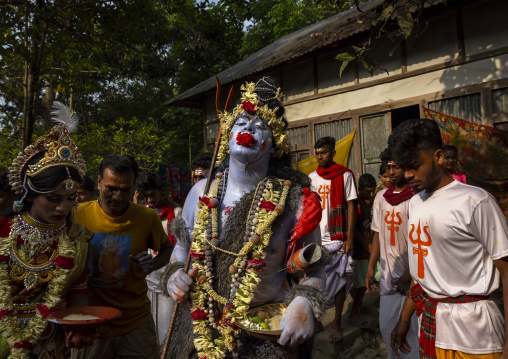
[0,0,362,174]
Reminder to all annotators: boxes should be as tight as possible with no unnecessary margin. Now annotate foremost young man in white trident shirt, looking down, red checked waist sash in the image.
[388,119,508,359]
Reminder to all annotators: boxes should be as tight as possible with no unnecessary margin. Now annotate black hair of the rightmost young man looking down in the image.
[388,118,443,167]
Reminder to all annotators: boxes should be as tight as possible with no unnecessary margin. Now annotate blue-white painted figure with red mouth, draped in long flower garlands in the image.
[161,78,325,359]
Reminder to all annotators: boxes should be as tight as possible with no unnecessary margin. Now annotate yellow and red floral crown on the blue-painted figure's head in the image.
[216,78,289,166]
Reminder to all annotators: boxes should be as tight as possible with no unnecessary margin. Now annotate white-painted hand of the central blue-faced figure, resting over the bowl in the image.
[278,297,314,346]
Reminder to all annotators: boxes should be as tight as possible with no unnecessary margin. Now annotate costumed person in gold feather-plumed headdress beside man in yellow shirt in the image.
[0,102,93,359]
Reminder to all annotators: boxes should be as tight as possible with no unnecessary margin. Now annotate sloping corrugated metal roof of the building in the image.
[166,0,439,105]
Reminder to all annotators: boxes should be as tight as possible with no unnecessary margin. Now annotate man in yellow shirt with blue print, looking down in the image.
[73,154,172,359]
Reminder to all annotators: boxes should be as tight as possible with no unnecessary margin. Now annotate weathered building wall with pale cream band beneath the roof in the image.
[205,0,508,180]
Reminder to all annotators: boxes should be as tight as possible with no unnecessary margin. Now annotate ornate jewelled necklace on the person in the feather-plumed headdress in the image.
[10,212,66,257]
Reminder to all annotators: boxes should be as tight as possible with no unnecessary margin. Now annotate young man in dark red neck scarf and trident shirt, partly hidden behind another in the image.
[365,149,418,359]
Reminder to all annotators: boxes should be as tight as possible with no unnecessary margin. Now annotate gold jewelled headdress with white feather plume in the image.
[9,101,86,211]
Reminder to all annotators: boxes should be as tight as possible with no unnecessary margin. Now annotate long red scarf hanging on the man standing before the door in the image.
[316,162,354,241]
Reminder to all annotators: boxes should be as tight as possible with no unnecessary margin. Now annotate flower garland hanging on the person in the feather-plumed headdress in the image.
[0,217,76,359]
